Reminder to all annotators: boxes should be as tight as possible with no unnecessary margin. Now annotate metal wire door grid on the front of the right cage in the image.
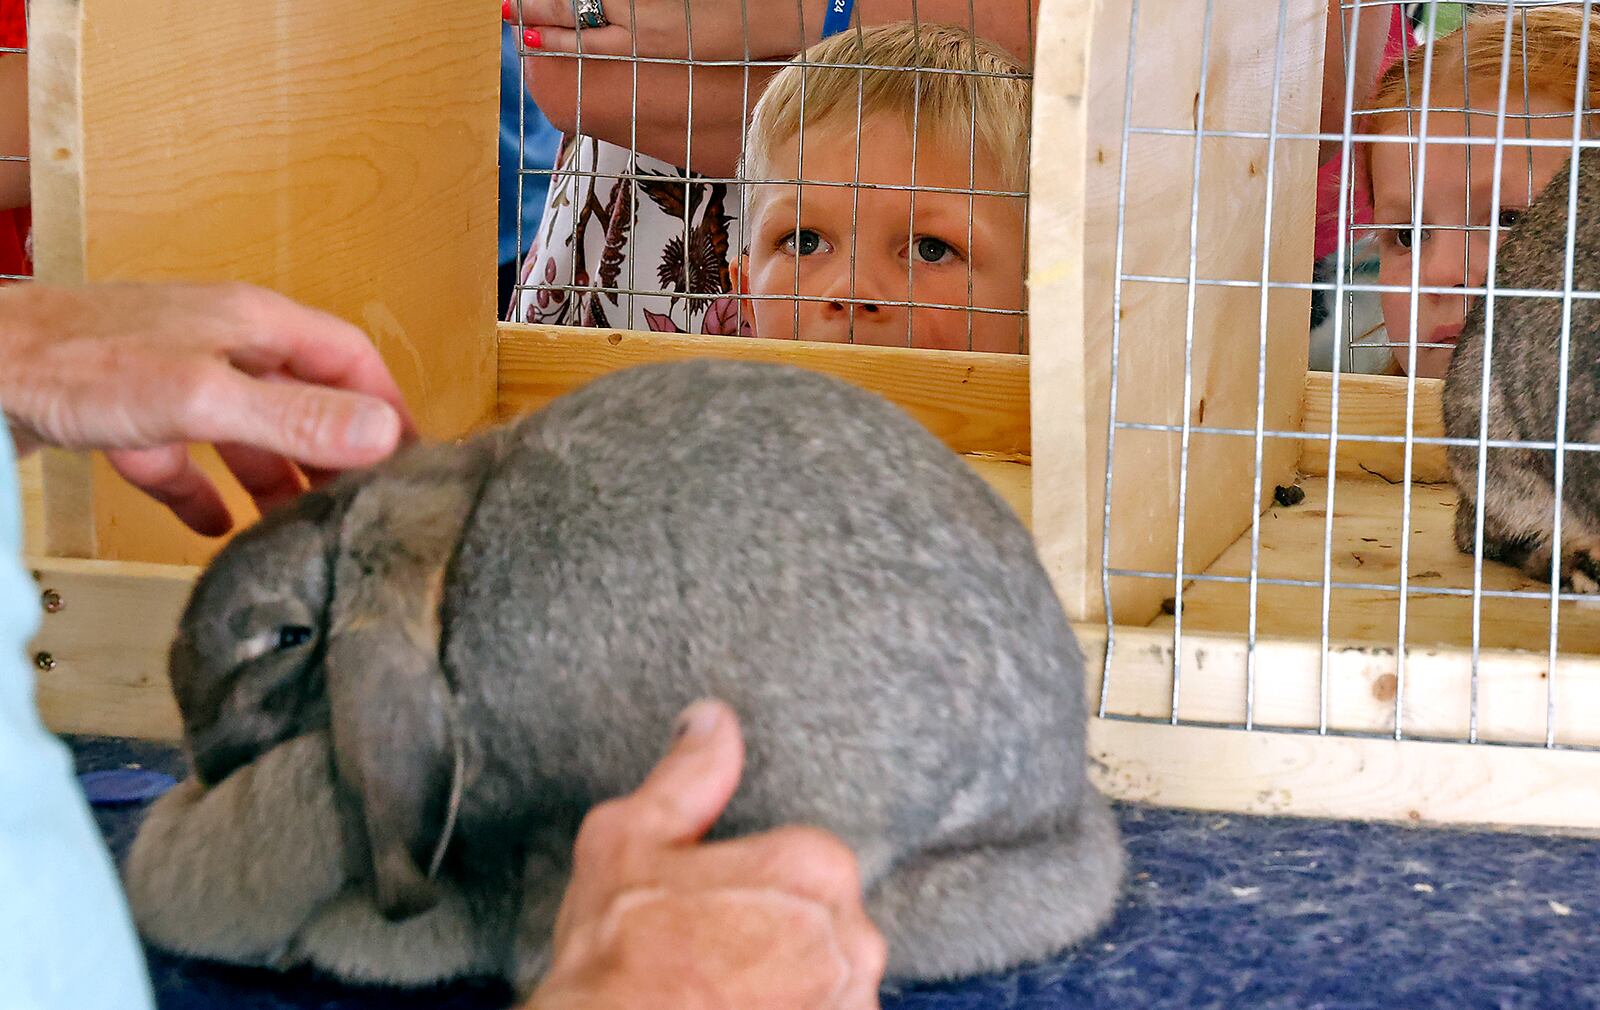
[1098,0,1600,749]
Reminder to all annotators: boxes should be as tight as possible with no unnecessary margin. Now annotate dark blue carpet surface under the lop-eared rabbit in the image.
[70,738,1600,1010]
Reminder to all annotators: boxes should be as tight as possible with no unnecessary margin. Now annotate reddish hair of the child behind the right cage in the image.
[1368,5,1600,115]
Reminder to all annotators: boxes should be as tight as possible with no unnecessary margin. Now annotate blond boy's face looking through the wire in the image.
[741,122,1026,354]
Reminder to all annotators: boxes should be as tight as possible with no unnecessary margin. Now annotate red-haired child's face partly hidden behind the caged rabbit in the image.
[1371,92,1573,378]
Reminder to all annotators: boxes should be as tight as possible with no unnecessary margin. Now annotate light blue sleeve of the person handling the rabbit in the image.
[0,432,150,1010]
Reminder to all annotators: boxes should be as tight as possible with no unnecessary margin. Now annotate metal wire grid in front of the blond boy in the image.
[514,0,1034,352]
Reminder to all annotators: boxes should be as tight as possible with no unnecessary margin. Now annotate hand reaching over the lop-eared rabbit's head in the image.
[0,283,413,536]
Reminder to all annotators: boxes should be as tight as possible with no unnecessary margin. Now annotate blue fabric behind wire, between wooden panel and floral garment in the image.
[499,24,562,264]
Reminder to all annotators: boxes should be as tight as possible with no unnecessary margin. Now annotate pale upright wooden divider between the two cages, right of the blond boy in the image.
[1029,0,1326,623]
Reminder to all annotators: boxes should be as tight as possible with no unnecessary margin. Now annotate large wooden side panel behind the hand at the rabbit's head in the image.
[30,0,499,562]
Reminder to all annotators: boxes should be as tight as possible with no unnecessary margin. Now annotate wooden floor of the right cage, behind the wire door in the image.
[1154,477,1600,655]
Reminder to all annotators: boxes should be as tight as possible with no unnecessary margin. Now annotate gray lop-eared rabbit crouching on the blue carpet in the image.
[128,360,1123,988]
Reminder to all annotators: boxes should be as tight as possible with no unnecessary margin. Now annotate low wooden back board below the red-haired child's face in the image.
[1299,371,1450,483]
